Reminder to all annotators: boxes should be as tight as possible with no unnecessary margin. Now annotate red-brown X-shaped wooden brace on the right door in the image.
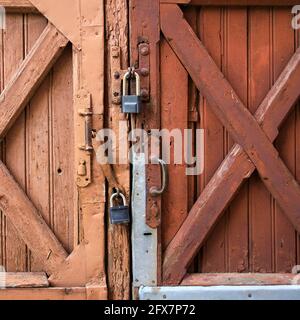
[161,4,300,285]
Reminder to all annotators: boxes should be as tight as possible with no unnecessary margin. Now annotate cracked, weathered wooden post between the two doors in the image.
[106,0,131,300]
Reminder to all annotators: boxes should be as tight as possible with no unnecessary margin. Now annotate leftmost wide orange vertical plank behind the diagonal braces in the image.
[3,14,27,271]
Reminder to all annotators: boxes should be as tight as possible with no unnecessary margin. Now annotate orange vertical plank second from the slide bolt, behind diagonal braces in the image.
[24,14,50,271]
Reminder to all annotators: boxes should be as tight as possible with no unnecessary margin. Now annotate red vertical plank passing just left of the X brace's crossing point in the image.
[223,8,249,272]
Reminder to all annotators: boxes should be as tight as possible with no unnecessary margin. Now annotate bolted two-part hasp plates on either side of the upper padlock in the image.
[111,43,150,105]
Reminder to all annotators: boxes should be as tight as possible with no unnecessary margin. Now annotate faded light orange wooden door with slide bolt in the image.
[0,0,106,299]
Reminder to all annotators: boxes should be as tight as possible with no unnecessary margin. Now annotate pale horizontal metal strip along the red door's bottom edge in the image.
[139,285,300,300]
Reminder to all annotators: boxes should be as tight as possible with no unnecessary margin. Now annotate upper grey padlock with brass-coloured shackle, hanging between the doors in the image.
[122,71,141,113]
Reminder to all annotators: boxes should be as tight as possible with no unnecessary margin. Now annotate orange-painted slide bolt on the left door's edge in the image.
[75,90,93,188]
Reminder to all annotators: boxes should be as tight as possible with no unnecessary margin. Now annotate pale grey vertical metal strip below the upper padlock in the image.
[132,153,158,288]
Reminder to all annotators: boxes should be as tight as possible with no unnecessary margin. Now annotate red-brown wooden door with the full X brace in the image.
[131,0,300,292]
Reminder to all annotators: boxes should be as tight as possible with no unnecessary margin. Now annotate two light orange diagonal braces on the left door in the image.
[0,23,69,274]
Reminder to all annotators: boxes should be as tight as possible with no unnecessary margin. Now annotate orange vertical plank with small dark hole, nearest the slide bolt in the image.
[50,46,75,252]
